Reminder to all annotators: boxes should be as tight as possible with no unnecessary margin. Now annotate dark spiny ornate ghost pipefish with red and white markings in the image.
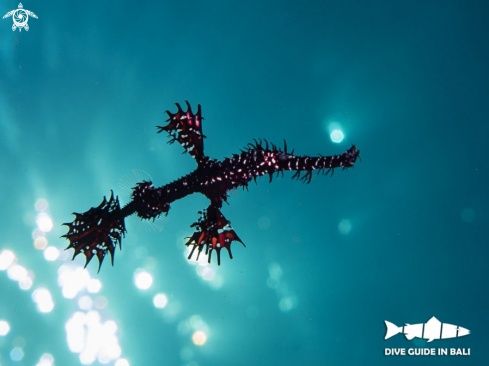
[62,101,360,271]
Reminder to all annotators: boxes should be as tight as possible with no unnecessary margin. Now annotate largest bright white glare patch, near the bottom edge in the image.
[65,311,122,365]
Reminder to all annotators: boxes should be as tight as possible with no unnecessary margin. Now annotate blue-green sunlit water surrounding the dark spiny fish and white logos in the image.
[0,0,489,366]
